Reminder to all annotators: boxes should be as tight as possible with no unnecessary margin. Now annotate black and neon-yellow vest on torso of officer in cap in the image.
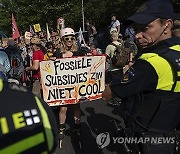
[136,40,180,133]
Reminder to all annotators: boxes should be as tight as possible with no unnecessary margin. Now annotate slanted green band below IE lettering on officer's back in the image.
[0,132,45,154]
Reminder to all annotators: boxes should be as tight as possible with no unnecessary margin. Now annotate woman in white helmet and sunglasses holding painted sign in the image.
[53,28,84,148]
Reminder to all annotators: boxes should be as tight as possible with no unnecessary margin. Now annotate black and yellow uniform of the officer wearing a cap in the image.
[110,37,180,153]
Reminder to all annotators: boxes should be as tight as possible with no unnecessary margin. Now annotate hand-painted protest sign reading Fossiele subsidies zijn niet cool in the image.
[40,55,106,106]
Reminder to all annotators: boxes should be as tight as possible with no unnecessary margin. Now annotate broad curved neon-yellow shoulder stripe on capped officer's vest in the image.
[140,53,174,91]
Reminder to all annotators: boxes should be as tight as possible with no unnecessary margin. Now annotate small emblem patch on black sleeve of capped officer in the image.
[121,67,135,83]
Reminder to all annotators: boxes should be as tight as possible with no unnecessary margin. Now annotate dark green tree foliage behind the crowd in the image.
[0,0,179,36]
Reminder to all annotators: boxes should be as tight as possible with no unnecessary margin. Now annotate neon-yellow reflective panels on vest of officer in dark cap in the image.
[140,45,180,92]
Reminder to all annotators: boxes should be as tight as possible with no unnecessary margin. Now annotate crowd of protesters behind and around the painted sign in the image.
[0,10,179,152]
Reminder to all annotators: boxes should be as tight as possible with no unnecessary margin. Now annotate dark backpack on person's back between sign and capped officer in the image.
[111,43,131,67]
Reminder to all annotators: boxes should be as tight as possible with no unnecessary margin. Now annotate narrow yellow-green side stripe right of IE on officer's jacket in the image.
[35,97,54,150]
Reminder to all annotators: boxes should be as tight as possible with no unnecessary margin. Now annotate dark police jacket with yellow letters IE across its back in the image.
[0,79,58,154]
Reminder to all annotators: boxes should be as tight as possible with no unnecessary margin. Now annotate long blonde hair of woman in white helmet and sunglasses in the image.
[60,39,78,53]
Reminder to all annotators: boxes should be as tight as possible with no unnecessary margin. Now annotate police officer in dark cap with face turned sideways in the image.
[103,0,180,154]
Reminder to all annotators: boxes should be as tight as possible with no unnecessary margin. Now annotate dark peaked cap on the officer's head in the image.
[127,0,174,24]
